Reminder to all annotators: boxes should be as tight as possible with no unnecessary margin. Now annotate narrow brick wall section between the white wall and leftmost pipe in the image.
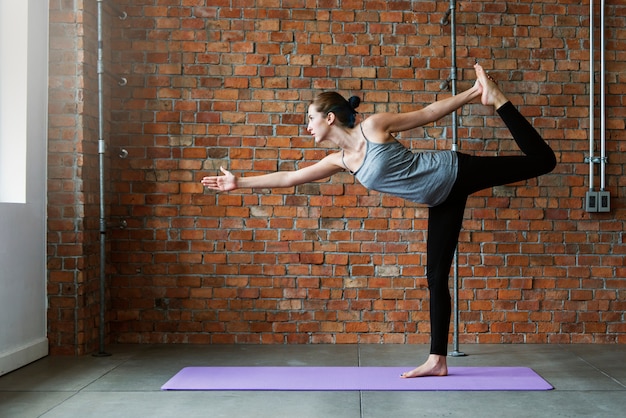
[47,0,108,354]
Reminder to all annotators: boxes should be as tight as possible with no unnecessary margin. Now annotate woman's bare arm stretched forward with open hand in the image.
[200,153,342,192]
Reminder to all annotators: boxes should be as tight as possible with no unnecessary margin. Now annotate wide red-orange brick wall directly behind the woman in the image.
[51,0,626,352]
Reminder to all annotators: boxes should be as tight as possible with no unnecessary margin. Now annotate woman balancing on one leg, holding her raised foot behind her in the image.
[201,64,556,378]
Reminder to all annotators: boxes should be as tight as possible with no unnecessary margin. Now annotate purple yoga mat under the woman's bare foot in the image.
[161,367,553,391]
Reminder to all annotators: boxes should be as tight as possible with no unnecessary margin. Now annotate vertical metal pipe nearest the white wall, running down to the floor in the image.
[94,0,110,356]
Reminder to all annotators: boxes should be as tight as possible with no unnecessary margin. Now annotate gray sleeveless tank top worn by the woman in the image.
[342,127,458,206]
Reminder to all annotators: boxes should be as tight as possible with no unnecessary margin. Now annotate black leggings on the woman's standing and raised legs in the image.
[426,102,556,355]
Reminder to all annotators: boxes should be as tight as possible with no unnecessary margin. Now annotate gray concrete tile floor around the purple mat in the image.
[0,345,626,418]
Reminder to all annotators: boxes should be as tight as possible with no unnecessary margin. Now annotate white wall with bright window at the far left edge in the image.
[0,0,49,375]
